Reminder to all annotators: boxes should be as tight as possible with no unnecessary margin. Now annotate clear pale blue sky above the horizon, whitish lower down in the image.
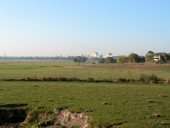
[0,0,170,56]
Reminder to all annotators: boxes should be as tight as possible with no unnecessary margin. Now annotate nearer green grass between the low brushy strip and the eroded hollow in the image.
[0,82,170,128]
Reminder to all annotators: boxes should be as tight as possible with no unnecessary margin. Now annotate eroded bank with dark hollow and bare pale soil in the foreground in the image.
[0,104,89,128]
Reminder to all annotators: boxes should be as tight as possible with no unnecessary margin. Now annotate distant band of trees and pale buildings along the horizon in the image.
[0,51,170,63]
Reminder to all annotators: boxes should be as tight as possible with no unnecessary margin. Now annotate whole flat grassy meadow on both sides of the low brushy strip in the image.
[0,61,170,128]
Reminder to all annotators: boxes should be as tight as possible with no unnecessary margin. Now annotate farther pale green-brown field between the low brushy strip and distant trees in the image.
[0,61,170,79]
